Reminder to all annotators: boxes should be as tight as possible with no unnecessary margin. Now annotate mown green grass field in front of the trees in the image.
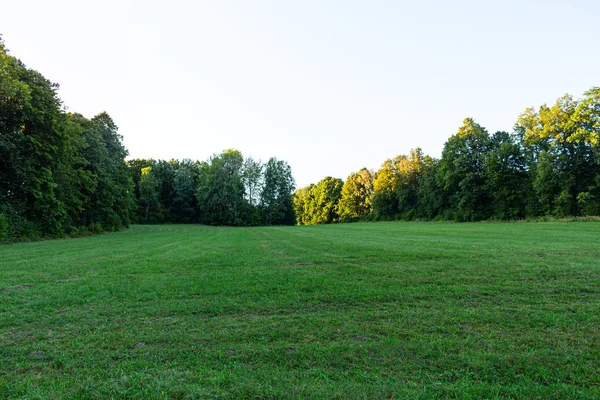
[0,222,600,399]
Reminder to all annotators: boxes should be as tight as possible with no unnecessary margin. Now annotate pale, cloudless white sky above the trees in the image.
[0,0,600,186]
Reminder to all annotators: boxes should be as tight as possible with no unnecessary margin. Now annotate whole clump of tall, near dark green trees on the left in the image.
[0,37,132,240]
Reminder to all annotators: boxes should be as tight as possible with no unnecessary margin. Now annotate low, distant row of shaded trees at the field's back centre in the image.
[128,149,295,226]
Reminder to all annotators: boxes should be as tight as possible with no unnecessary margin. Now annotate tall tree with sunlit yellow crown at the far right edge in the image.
[515,94,599,216]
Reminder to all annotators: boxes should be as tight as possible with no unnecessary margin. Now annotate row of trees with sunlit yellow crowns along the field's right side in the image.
[293,87,600,225]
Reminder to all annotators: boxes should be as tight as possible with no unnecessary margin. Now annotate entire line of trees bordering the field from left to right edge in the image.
[0,37,600,242]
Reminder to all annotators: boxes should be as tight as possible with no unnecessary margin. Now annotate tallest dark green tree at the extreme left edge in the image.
[0,47,65,235]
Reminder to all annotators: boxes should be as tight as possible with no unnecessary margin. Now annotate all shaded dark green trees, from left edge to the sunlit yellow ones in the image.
[0,37,295,242]
